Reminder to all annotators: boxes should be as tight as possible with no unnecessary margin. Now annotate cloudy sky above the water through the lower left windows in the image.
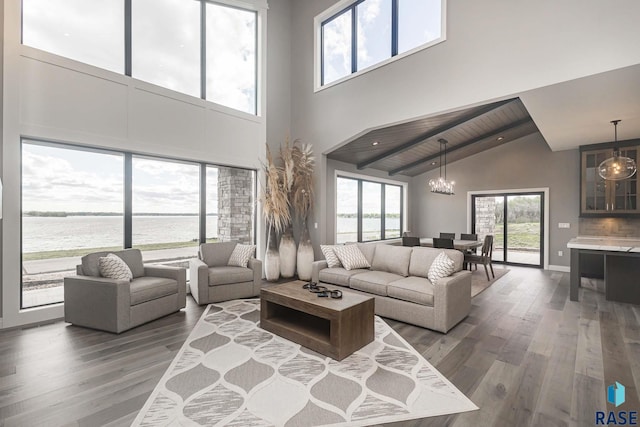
[22,143,218,213]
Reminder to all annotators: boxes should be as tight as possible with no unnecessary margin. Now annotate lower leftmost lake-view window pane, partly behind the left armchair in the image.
[21,141,124,308]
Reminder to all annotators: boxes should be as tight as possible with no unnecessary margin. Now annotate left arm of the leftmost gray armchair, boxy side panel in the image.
[64,276,131,333]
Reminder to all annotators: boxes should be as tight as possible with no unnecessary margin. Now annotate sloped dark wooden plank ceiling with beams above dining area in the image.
[327,98,538,176]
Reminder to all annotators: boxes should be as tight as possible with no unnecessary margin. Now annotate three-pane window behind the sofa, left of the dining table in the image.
[336,177,403,243]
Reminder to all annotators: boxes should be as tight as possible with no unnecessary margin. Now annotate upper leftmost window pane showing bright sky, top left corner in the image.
[22,0,124,73]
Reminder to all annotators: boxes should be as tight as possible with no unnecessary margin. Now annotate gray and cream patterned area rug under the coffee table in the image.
[133,299,478,427]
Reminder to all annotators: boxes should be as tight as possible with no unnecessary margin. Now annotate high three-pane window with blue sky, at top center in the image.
[320,0,445,85]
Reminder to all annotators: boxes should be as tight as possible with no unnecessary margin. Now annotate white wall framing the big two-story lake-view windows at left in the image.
[2,0,270,327]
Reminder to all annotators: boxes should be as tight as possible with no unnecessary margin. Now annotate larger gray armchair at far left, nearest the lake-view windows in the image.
[64,249,187,333]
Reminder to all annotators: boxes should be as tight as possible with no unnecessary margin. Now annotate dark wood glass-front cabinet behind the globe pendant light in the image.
[580,140,640,217]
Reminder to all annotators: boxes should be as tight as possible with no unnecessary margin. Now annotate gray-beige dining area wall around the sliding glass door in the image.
[410,133,580,267]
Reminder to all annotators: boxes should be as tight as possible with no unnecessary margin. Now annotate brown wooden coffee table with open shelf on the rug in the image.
[260,281,374,360]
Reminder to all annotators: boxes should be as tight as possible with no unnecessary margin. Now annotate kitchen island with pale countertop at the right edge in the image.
[567,236,640,304]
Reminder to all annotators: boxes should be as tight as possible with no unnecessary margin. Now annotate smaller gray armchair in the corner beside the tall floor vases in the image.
[189,242,262,305]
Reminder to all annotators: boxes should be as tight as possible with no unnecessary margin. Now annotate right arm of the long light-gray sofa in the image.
[433,270,471,333]
